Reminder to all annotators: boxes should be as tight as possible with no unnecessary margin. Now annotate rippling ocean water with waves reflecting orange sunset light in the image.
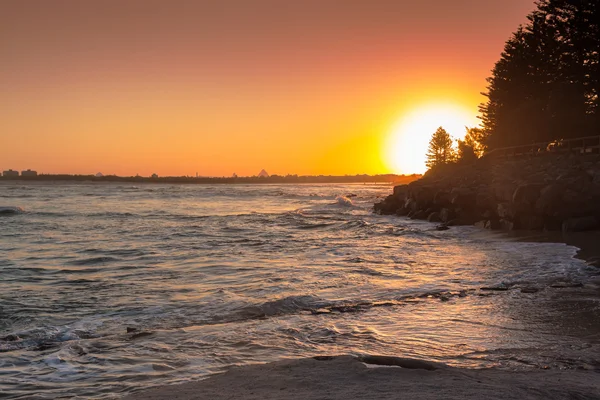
[0,182,600,399]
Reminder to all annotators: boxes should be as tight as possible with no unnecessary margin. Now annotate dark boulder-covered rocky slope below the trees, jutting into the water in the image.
[374,154,600,232]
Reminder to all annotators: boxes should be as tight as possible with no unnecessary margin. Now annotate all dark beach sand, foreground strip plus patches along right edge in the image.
[125,232,600,400]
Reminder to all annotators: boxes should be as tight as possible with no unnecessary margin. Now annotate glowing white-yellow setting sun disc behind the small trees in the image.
[384,104,479,174]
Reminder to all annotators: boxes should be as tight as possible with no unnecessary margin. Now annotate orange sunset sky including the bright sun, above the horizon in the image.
[0,0,534,176]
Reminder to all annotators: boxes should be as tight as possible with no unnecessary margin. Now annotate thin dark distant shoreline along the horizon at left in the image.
[0,174,421,184]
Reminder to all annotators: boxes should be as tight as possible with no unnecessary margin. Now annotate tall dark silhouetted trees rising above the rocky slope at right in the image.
[480,0,600,149]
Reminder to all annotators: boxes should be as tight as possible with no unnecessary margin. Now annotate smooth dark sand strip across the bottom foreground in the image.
[126,356,600,400]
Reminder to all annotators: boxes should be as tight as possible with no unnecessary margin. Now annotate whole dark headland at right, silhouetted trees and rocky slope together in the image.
[375,0,600,232]
